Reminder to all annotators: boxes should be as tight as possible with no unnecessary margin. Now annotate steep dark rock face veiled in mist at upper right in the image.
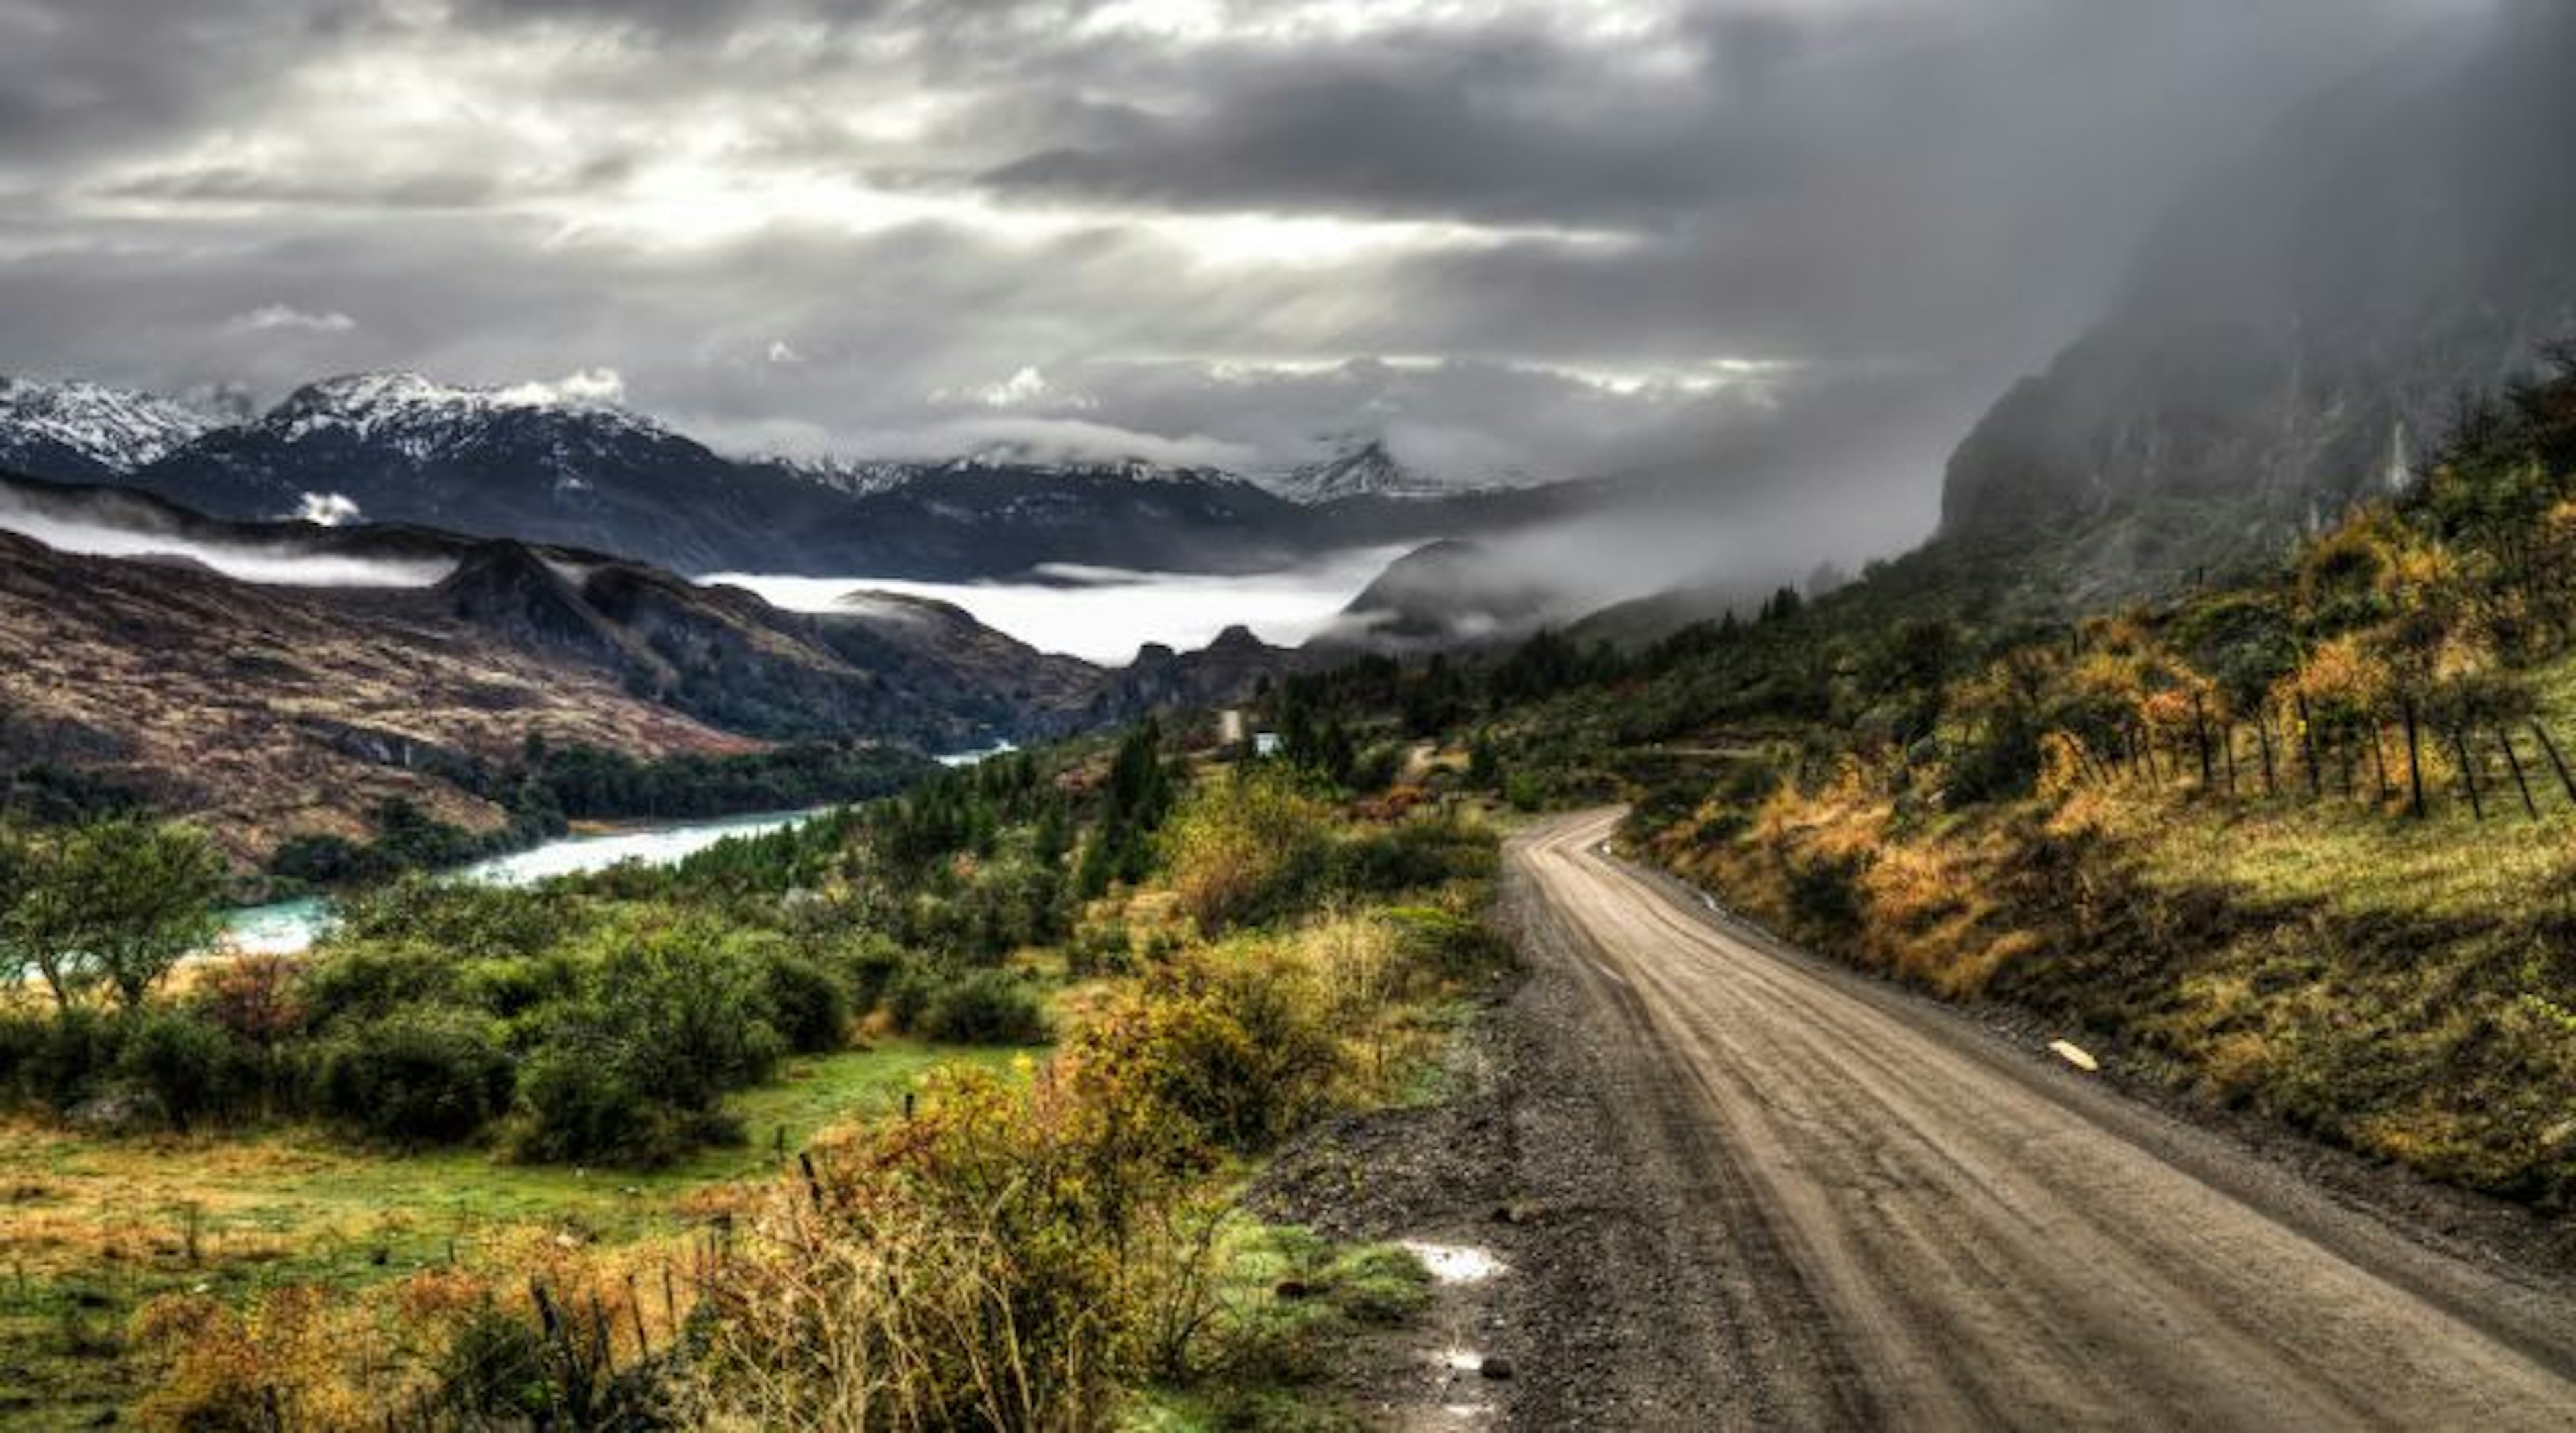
[1942,0,2576,577]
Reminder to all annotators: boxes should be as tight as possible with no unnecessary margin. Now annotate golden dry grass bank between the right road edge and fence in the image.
[1656,752,2576,1206]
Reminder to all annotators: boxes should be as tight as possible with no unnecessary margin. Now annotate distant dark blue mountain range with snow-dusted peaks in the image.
[0,374,1589,580]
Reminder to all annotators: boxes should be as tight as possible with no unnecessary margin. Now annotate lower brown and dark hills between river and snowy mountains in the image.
[0,474,1301,861]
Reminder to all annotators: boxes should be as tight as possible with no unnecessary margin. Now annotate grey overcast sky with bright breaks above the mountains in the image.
[0,0,2478,543]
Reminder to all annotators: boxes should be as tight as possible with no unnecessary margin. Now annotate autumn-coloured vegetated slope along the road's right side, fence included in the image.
[1293,353,2576,1212]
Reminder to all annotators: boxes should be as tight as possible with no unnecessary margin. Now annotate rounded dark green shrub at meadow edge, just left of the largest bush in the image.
[314,1005,515,1145]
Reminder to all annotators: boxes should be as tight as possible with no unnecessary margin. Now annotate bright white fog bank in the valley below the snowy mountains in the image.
[706,546,1407,665]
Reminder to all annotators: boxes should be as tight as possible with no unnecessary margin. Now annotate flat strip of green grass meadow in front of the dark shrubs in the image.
[0,1041,1025,1428]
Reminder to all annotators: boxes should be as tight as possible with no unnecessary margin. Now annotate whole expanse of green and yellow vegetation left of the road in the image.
[0,727,1502,1430]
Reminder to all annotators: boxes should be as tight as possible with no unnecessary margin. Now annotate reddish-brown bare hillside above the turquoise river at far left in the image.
[0,533,755,858]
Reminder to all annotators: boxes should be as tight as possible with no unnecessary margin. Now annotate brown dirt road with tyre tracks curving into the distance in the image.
[1507,812,2576,1430]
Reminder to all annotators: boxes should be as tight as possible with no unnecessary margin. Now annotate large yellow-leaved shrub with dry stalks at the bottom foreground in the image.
[683,1069,1143,1428]
